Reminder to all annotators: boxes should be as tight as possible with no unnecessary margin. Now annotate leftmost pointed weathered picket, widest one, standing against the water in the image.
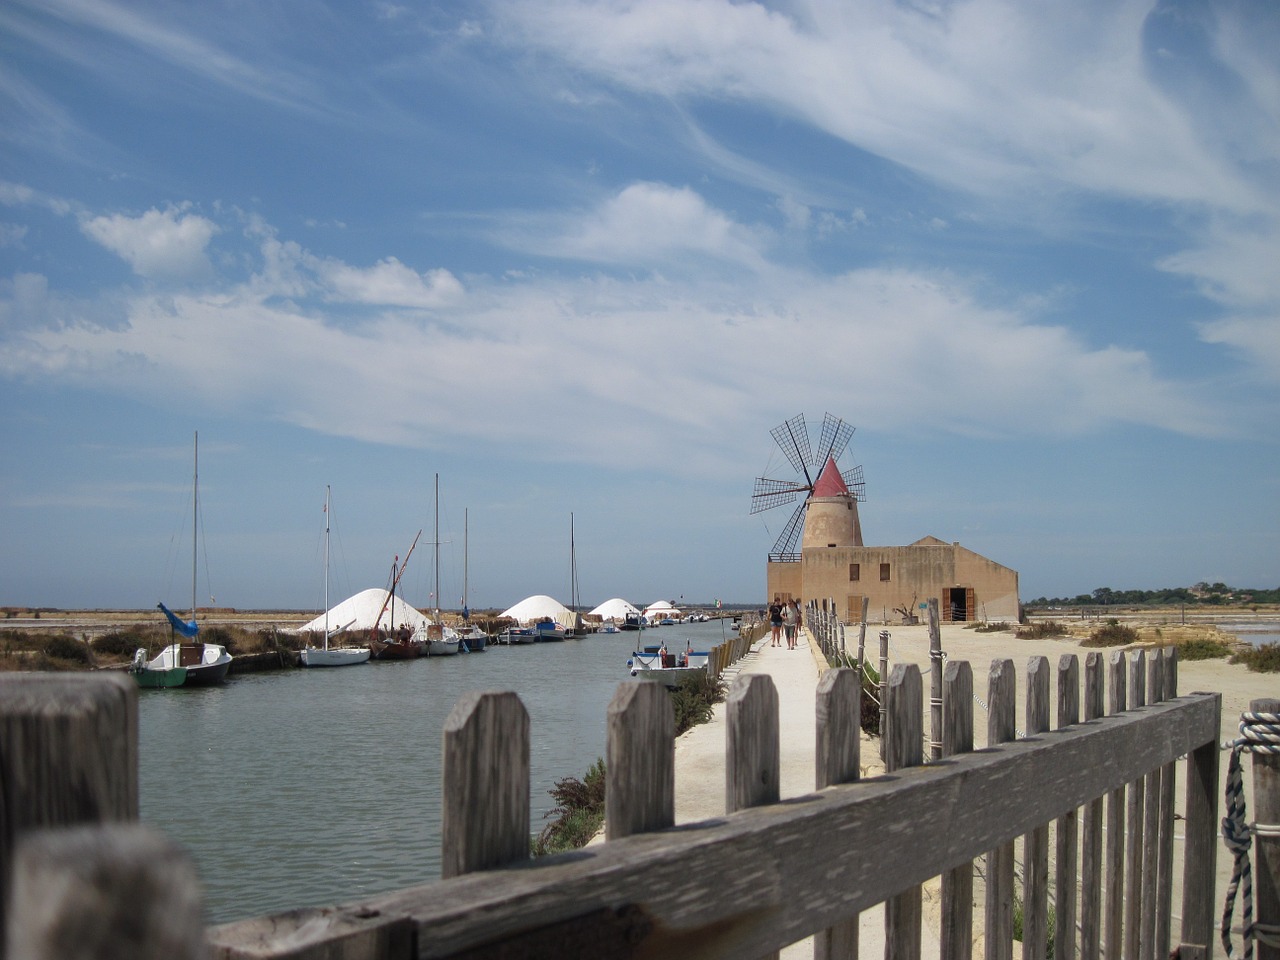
[440,691,529,879]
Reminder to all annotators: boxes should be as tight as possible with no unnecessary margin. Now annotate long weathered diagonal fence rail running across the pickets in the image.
[209,694,1221,960]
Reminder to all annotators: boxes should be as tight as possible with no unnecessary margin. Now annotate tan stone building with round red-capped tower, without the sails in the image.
[767,458,1019,623]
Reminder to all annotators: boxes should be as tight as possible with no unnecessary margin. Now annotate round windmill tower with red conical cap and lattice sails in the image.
[751,413,867,563]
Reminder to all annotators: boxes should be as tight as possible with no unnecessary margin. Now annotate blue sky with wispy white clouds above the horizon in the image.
[0,0,1280,609]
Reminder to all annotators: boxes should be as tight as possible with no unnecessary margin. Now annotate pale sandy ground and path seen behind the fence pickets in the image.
[676,625,1280,960]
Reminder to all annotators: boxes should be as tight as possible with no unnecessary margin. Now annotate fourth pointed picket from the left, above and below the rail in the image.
[813,668,863,960]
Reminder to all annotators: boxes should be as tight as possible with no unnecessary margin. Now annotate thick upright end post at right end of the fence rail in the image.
[1178,694,1222,960]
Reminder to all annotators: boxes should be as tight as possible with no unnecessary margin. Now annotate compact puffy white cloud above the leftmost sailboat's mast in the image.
[81,207,218,279]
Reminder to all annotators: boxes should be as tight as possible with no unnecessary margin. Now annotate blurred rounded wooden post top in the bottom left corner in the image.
[8,829,206,960]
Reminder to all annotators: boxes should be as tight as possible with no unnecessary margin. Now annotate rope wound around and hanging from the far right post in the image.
[1222,713,1280,960]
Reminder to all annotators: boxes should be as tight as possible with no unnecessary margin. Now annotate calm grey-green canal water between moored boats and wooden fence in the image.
[138,621,728,923]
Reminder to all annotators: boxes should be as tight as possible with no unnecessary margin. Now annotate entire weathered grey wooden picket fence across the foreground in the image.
[0,653,1239,960]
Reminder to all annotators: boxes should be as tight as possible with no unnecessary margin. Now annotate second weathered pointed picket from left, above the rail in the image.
[604,682,676,840]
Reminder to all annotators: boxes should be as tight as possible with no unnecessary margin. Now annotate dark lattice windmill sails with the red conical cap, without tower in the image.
[751,413,867,562]
